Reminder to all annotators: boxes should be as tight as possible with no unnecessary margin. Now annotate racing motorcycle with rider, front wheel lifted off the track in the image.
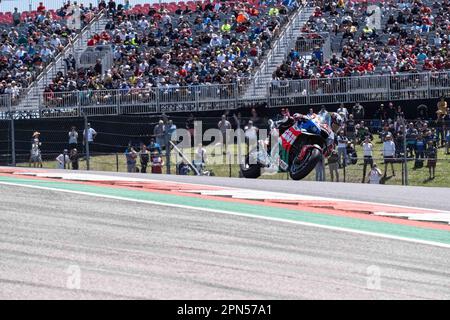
[241,113,342,180]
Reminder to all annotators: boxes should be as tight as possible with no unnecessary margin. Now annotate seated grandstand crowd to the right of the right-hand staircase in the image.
[274,0,450,79]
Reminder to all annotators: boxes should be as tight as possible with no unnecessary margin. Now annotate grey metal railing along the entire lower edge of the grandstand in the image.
[0,71,450,116]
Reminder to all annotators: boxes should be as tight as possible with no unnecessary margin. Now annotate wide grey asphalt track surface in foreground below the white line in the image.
[0,184,450,299]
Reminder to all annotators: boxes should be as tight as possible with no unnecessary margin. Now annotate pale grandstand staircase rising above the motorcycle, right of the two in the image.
[244,7,314,99]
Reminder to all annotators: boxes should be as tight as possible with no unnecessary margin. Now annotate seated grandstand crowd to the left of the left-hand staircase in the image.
[0,1,97,99]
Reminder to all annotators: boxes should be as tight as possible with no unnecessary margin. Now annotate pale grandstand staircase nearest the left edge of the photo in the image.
[15,12,108,110]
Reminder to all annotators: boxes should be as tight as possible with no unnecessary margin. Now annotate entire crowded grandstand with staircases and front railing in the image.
[0,0,450,116]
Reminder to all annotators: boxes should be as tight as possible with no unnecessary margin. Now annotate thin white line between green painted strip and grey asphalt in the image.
[0,181,450,249]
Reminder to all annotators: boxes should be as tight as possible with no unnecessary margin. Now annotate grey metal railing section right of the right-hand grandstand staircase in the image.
[267,72,450,107]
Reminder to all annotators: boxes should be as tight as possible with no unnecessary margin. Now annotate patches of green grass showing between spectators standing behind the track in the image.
[18,142,450,187]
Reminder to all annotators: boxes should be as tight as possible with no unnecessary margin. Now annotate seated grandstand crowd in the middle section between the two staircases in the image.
[45,0,298,97]
